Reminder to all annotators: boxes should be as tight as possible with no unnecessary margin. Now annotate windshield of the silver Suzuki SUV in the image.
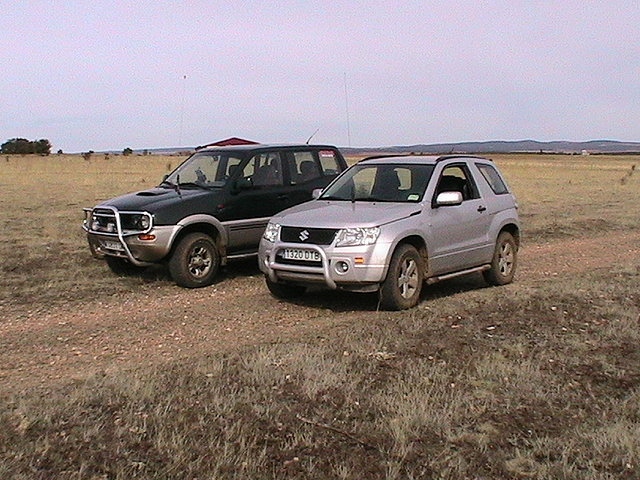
[320,164,434,203]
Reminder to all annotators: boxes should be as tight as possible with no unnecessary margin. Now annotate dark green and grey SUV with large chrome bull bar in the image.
[83,145,346,288]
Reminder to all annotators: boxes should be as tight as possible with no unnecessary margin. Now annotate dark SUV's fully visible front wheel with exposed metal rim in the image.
[169,233,220,288]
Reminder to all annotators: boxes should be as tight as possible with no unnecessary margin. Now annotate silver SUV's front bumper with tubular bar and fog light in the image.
[258,238,391,291]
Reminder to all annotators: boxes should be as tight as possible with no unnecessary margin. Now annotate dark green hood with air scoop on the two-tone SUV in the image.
[98,187,220,225]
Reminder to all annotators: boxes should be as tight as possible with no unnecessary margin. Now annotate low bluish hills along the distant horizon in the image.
[102,140,640,155]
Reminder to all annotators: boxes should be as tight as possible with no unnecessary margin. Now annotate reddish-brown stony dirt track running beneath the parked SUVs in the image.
[0,232,640,394]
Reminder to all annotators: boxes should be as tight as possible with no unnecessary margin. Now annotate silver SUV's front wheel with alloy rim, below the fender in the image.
[380,244,424,310]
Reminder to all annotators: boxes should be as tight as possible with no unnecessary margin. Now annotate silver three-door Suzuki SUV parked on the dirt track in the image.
[259,155,520,310]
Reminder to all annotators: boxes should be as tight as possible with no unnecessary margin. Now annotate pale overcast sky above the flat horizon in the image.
[0,0,640,152]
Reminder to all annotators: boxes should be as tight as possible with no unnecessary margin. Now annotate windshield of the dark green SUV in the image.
[161,152,242,188]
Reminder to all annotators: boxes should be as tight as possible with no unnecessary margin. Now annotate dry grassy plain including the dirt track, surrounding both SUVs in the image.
[0,154,640,480]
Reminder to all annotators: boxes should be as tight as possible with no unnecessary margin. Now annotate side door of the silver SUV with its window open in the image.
[427,160,491,275]
